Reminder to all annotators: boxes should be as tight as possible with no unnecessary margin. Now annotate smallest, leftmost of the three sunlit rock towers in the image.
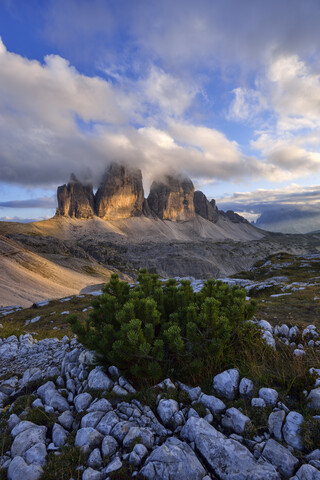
[56,174,94,219]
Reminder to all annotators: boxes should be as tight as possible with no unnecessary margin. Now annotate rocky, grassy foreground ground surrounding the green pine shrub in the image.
[0,252,320,480]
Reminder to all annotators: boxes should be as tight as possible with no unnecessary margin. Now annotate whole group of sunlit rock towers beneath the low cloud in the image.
[56,163,248,223]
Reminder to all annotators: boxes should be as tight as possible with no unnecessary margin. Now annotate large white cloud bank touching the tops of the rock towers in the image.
[0,38,284,189]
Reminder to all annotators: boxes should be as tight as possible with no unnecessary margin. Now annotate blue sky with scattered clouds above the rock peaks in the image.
[0,0,320,221]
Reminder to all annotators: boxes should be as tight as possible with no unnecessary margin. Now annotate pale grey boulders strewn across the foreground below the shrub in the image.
[0,335,320,480]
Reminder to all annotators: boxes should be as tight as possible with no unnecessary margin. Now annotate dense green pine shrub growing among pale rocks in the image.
[69,270,263,382]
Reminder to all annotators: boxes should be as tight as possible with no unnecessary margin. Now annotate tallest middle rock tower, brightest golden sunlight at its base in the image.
[95,163,144,220]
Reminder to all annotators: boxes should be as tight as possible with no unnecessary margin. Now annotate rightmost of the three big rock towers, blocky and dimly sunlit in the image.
[148,175,195,221]
